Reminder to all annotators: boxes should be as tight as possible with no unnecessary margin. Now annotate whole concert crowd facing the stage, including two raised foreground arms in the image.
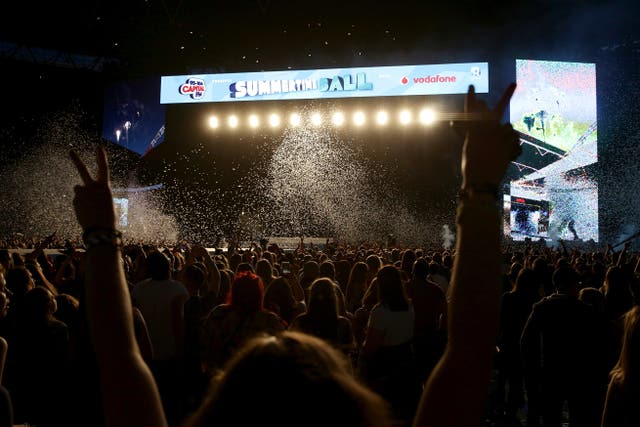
[0,85,640,427]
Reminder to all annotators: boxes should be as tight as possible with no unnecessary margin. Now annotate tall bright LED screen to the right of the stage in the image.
[504,59,598,242]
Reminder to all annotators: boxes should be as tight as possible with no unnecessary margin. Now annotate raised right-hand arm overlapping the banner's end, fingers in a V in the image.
[415,84,520,427]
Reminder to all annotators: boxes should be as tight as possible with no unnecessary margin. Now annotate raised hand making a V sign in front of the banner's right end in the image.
[462,83,522,189]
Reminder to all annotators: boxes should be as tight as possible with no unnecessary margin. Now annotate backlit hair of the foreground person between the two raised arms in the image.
[186,332,391,427]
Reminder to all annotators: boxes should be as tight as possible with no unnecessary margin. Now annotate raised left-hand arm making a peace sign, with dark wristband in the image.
[70,148,167,427]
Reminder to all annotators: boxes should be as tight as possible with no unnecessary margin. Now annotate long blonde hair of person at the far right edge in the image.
[611,305,640,389]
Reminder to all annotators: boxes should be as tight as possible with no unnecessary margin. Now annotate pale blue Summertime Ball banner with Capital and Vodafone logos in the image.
[160,62,489,104]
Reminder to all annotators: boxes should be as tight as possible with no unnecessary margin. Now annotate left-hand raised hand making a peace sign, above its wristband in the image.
[69,147,116,230]
